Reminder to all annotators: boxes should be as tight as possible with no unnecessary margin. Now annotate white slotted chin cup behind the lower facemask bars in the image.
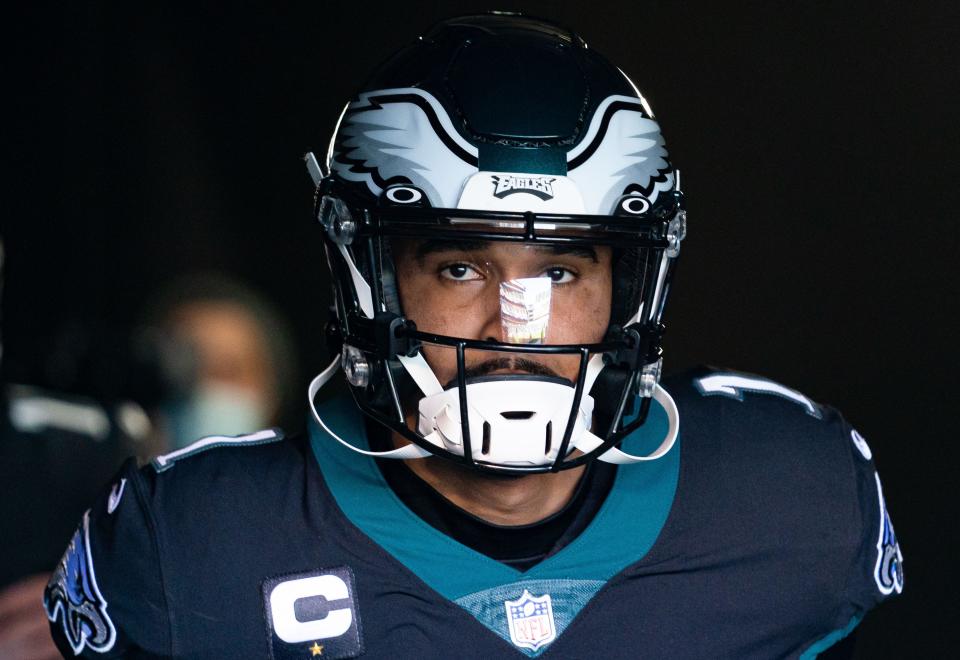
[418,377,593,466]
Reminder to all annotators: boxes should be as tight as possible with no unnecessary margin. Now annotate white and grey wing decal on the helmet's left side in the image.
[329,87,477,207]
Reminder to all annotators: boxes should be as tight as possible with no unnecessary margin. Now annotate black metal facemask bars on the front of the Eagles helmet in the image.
[316,177,683,474]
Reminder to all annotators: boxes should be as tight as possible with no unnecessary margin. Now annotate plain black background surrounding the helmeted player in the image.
[0,1,960,658]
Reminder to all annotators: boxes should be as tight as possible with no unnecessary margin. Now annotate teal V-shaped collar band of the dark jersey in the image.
[310,397,680,600]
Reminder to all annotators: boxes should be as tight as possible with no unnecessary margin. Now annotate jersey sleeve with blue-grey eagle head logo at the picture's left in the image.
[44,459,171,658]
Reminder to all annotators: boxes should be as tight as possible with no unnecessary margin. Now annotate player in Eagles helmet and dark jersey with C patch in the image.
[45,13,903,659]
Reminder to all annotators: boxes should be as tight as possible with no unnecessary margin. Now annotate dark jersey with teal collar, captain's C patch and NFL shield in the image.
[45,370,903,660]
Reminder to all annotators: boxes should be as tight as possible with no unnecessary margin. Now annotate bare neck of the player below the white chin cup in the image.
[393,428,584,527]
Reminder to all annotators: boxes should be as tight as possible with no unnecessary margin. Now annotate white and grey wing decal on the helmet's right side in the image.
[567,96,673,214]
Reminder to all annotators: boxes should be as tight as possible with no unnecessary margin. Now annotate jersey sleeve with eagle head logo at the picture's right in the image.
[842,421,903,612]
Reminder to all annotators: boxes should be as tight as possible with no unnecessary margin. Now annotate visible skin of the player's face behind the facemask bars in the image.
[393,240,612,387]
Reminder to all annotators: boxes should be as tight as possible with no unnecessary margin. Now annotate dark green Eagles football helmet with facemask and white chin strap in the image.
[305,13,686,474]
